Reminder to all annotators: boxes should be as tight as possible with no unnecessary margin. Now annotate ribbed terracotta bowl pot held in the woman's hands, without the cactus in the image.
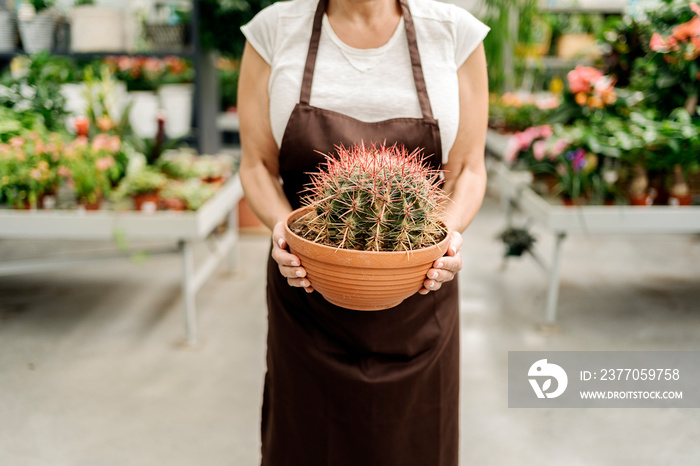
[285,207,449,311]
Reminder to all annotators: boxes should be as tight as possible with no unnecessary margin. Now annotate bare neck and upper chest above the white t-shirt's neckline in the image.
[326,0,401,49]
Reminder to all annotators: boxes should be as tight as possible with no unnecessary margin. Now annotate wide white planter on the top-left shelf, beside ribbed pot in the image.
[70,5,125,52]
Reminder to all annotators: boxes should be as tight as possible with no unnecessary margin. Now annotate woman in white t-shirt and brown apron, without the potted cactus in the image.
[239,0,488,466]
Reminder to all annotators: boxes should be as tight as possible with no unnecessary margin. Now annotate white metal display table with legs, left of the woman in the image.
[0,174,243,345]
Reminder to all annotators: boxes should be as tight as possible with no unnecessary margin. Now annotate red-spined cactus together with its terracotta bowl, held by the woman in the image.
[286,144,449,311]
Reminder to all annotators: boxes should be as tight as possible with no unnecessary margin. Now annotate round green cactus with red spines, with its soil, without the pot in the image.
[292,143,447,251]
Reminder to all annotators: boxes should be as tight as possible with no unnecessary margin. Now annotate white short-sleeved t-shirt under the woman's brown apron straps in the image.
[241,0,489,163]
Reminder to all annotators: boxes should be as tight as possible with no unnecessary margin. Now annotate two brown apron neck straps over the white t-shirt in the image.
[299,0,434,121]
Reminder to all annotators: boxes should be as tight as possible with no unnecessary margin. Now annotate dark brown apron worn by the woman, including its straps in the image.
[261,0,459,466]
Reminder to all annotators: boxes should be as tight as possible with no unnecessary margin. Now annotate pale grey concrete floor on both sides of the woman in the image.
[0,195,700,466]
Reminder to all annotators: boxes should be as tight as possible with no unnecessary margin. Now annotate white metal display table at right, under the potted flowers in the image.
[489,162,700,325]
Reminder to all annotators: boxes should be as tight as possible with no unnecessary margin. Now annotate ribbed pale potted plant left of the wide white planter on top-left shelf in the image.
[17,0,56,53]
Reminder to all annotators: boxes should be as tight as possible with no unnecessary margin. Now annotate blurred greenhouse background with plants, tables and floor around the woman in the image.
[0,0,700,466]
